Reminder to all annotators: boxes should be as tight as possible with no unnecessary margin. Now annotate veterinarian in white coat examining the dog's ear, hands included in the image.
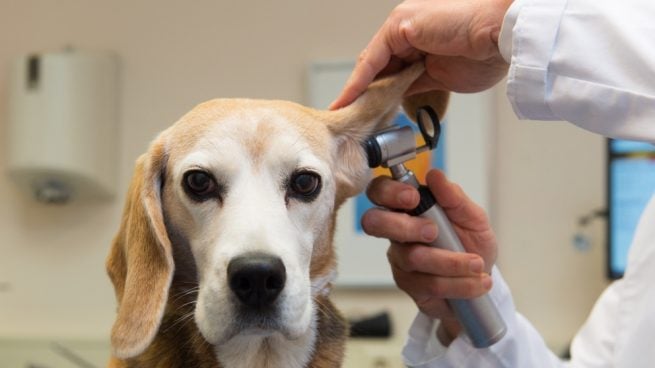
[333,0,655,368]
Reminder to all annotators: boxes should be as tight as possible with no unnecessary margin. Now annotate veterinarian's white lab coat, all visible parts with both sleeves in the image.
[403,0,655,368]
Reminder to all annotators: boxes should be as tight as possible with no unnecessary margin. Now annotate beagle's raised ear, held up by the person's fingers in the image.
[326,62,448,201]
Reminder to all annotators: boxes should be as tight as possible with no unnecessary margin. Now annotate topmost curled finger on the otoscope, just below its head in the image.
[366,176,420,210]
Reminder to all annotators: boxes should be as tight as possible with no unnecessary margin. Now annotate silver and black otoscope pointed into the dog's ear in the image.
[364,106,507,348]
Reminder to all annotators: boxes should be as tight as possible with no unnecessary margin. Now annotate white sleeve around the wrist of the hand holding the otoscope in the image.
[403,268,566,368]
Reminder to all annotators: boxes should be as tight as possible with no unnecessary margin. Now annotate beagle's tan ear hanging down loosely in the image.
[106,139,174,358]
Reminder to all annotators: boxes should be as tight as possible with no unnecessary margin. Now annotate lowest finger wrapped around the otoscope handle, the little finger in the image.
[392,265,492,303]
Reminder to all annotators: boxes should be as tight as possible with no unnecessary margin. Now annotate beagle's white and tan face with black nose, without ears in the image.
[163,100,339,345]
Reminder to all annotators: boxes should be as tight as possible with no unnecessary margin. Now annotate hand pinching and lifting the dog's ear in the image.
[330,0,512,109]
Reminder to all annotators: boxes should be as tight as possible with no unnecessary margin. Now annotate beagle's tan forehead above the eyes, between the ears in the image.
[167,99,331,160]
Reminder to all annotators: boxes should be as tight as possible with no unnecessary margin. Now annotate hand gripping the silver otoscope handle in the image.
[362,170,497,345]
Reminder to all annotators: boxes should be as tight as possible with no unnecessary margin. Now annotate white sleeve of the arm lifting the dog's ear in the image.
[499,0,655,142]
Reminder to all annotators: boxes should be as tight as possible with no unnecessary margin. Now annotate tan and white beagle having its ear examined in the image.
[107,64,448,368]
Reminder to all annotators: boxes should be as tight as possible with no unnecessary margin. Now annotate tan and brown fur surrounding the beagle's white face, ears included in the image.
[106,64,448,368]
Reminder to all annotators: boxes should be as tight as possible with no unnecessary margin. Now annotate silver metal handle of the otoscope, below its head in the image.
[392,170,507,348]
